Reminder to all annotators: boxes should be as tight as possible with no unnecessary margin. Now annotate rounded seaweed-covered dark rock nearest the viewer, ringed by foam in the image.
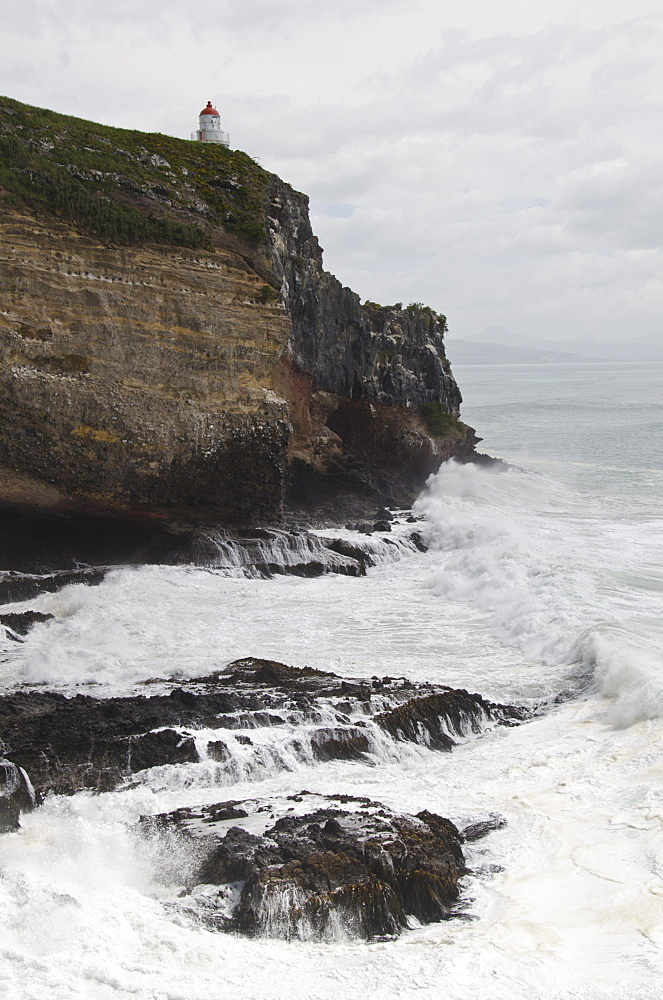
[141,792,466,940]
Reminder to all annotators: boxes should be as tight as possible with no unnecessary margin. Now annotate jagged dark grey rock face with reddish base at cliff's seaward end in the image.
[267,177,477,511]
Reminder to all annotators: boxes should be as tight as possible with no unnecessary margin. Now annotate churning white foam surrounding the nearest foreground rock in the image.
[0,703,663,1000]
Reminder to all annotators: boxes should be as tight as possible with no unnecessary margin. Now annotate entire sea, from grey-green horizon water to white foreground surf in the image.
[0,364,663,1000]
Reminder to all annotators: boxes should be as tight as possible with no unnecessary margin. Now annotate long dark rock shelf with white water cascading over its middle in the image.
[0,657,526,794]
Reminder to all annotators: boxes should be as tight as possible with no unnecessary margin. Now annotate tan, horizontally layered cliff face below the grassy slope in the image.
[0,215,290,520]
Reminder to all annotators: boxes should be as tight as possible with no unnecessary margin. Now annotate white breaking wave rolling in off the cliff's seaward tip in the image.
[417,462,663,725]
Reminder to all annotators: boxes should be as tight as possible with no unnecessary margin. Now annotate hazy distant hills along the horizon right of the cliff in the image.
[447,326,663,365]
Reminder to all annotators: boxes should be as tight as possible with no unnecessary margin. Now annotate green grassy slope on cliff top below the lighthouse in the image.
[0,97,270,247]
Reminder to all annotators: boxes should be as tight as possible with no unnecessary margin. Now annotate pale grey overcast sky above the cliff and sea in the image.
[0,0,663,338]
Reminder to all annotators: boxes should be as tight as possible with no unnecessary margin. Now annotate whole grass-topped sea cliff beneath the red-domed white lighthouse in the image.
[0,98,475,525]
